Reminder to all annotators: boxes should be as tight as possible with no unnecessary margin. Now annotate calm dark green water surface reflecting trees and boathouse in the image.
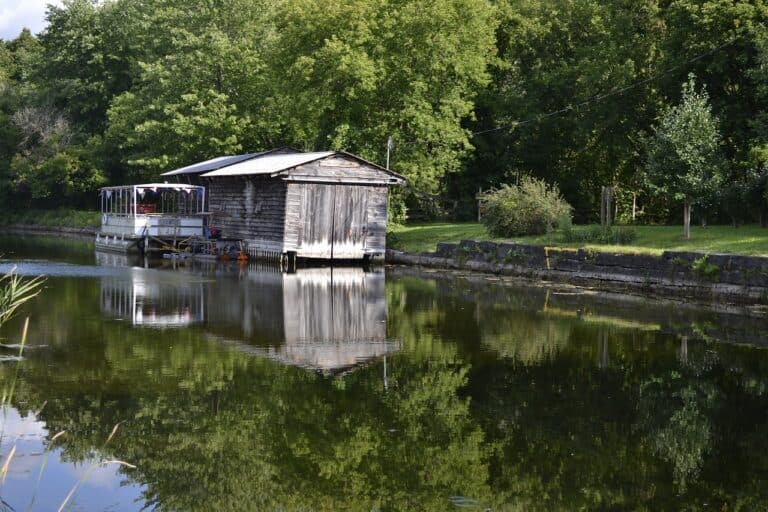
[0,237,768,511]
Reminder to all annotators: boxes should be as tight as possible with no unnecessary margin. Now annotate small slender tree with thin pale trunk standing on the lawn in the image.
[645,76,725,238]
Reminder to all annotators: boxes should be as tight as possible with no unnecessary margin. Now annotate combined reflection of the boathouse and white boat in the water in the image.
[101,266,399,373]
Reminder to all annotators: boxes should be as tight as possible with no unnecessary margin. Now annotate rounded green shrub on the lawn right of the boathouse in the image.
[481,176,572,236]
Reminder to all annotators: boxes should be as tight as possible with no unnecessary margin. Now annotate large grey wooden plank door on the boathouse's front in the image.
[298,183,368,259]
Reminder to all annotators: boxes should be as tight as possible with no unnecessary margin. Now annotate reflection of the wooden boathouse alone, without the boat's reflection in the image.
[206,268,399,373]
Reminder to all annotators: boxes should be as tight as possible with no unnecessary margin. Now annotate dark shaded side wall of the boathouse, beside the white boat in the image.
[208,177,290,252]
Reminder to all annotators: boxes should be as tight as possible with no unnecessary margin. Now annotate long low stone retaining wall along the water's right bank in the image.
[387,240,768,304]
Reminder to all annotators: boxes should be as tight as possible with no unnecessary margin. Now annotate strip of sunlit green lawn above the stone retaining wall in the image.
[391,223,768,256]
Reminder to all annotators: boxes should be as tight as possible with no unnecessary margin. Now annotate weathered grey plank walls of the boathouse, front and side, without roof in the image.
[208,155,393,258]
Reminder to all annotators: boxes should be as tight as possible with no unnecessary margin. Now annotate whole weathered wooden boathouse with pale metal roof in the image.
[164,150,405,260]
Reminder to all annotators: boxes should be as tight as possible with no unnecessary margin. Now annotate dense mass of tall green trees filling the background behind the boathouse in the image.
[0,0,768,223]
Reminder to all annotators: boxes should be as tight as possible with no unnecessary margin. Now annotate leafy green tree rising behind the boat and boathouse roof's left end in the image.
[106,0,275,179]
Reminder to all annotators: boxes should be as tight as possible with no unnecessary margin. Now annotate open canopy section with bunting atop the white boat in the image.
[99,183,205,216]
